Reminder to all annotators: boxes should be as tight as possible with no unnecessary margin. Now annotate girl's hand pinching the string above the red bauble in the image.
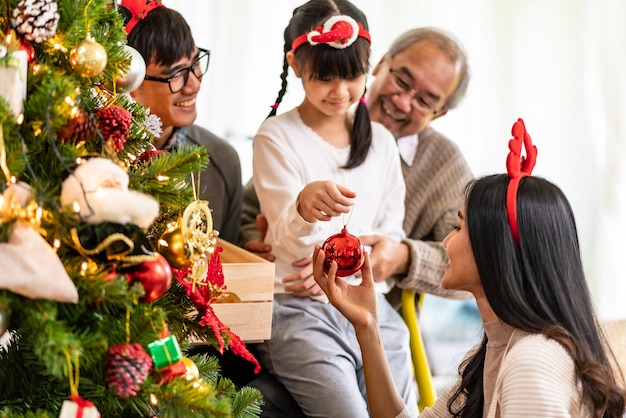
[297,181,356,223]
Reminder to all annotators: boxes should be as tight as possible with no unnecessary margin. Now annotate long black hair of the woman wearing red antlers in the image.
[448,174,626,418]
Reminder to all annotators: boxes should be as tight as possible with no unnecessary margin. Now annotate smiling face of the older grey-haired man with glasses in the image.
[368,40,459,138]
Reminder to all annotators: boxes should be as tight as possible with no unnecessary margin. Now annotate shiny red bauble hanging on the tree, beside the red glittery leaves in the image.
[125,253,172,302]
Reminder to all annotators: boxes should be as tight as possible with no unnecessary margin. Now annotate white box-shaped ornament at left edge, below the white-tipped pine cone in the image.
[0,45,28,116]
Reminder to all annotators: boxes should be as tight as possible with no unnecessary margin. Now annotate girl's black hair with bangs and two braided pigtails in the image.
[268,0,372,168]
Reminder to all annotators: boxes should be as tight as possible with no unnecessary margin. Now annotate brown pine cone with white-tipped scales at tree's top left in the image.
[11,0,59,43]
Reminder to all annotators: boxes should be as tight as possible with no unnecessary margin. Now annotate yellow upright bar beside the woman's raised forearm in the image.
[402,289,437,412]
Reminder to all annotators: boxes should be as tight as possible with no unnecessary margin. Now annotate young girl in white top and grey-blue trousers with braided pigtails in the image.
[253,0,417,418]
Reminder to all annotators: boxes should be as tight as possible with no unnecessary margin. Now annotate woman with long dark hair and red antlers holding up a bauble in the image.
[314,120,626,418]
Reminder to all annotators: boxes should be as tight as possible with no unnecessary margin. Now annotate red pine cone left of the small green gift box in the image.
[107,343,152,399]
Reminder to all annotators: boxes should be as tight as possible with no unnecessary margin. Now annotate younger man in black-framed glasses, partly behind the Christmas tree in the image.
[120,0,243,243]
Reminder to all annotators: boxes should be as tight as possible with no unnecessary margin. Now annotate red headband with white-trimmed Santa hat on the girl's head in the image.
[291,15,372,52]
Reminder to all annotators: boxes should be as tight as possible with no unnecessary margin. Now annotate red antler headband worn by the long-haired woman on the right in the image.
[506,119,537,245]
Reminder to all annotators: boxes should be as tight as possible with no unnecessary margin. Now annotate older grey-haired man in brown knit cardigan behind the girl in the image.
[241,28,473,417]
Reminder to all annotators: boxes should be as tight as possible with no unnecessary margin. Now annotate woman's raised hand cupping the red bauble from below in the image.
[313,245,376,329]
